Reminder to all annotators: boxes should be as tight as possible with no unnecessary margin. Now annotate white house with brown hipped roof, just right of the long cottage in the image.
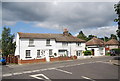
[86,37,105,56]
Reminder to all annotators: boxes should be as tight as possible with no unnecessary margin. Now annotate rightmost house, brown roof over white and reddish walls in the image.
[105,39,119,51]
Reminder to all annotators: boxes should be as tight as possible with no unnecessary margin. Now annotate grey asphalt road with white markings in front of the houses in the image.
[2,56,119,81]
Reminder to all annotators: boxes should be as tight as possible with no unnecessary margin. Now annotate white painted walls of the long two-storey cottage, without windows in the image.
[15,34,85,61]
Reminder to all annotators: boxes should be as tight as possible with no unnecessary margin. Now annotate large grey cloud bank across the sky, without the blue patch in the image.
[2,2,116,34]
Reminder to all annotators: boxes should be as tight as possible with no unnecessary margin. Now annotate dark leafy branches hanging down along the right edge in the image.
[114,2,120,47]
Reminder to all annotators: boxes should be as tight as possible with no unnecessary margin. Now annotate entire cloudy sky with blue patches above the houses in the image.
[0,1,117,37]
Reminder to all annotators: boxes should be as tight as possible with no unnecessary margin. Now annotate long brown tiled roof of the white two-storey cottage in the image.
[18,32,85,42]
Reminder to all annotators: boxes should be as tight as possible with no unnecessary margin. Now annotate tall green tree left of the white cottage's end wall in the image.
[2,27,15,56]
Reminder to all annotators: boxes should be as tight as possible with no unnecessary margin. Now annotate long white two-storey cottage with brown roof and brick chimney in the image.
[15,29,85,62]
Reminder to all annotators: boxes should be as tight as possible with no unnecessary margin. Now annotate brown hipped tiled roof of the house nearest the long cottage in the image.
[86,37,105,46]
